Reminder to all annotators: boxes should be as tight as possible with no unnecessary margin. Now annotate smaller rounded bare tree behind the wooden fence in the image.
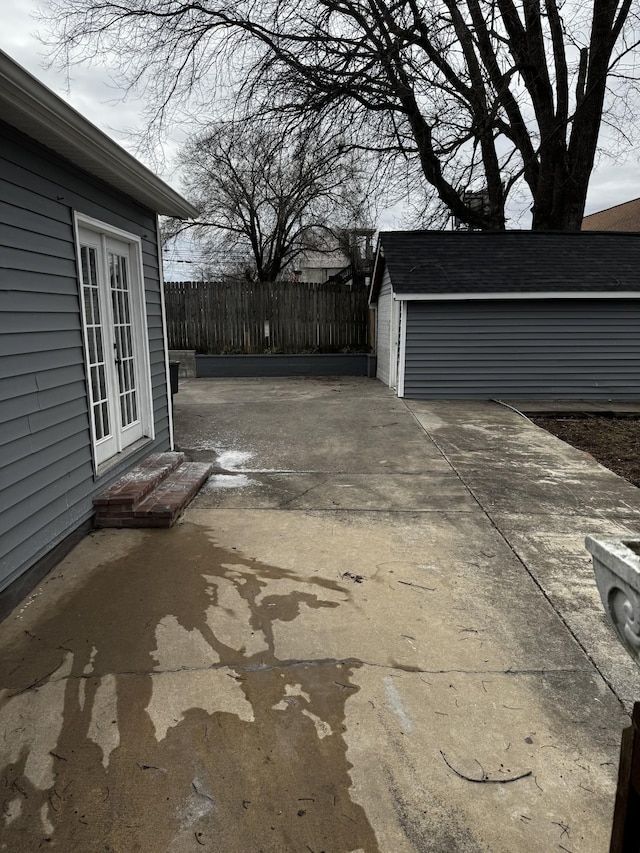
[165,121,368,281]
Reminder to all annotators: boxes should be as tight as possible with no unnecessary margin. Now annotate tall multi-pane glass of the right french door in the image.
[109,252,138,427]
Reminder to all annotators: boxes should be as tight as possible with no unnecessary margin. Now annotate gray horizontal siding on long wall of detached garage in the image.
[404,298,640,400]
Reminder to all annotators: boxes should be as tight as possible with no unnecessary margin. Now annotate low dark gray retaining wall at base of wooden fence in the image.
[196,353,375,377]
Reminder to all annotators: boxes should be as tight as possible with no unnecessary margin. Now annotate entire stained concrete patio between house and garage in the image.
[0,379,640,853]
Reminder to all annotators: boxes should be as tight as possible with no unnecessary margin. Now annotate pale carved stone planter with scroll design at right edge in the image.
[585,536,640,665]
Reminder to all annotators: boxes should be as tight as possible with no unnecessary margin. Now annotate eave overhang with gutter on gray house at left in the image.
[0,50,198,219]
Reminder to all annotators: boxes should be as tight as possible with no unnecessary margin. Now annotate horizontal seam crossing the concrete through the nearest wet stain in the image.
[5,658,592,699]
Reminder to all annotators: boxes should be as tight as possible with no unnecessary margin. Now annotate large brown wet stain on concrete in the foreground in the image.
[0,524,379,853]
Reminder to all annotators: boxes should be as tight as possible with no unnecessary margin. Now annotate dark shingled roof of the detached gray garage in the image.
[371,231,640,302]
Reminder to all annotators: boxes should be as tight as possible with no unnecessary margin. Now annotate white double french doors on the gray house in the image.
[78,220,150,465]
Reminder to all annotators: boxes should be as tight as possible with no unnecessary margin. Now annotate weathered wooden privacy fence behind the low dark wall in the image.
[165,281,369,355]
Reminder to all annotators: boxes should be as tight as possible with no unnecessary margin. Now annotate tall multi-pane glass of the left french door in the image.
[80,246,111,441]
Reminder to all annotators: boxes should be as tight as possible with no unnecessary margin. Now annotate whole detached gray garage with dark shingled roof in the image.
[370,231,640,400]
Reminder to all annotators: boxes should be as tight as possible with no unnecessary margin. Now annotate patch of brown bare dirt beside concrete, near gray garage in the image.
[531,414,640,486]
